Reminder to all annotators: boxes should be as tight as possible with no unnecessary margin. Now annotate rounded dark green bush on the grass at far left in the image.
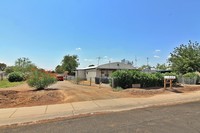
[8,72,25,82]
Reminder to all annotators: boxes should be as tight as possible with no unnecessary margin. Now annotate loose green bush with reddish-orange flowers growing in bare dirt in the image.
[27,70,57,90]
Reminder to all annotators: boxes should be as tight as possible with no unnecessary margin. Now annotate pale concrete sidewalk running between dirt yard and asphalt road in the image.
[0,91,200,126]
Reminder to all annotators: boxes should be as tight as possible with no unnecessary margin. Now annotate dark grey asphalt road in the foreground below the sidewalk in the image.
[0,102,200,133]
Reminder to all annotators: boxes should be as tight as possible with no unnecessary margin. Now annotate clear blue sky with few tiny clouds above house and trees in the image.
[0,0,200,70]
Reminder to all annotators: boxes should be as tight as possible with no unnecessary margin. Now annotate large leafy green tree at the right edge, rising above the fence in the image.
[169,41,200,74]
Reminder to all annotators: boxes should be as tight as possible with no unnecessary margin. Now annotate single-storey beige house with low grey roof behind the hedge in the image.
[76,62,136,81]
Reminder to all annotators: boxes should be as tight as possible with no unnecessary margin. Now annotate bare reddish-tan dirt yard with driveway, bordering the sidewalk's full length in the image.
[0,81,200,108]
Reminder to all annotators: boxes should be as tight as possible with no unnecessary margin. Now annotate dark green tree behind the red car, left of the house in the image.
[62,55,79,74]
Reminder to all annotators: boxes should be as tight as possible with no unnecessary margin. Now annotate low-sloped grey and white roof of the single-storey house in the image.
[77,62,136,70]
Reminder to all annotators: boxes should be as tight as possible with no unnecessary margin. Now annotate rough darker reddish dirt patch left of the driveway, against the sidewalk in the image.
[0,90,64,108]
